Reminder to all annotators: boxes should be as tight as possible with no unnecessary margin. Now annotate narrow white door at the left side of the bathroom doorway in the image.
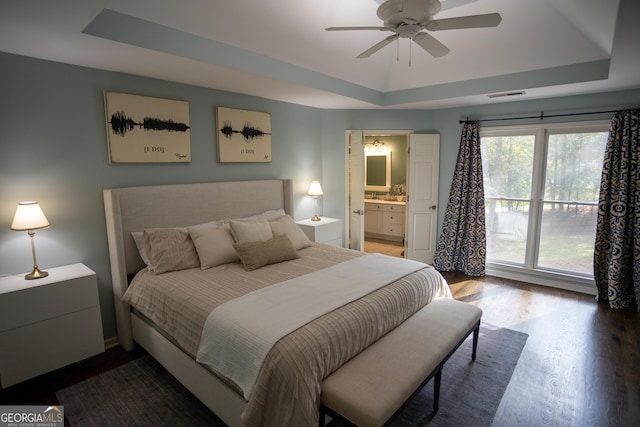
[347,131,364,251]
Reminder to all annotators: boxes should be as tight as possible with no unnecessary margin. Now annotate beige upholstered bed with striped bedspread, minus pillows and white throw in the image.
[104,180,458,427]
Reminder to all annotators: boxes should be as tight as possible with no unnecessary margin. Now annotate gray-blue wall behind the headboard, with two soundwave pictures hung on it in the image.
[0,54,322,337]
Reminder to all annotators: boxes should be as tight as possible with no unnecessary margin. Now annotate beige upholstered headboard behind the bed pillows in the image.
[103,179,293,349]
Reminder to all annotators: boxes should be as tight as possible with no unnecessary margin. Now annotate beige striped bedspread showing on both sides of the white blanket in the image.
[124,244,451,427]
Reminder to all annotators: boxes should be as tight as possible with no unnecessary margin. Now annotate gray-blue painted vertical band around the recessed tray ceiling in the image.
[83,9,610,107]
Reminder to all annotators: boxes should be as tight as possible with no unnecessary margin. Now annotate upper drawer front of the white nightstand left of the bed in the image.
[0,272,98,332]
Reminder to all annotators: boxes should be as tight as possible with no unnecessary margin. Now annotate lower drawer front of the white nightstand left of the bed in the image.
[0,307,104,388]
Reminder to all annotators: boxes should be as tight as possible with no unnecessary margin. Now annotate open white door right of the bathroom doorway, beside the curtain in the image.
[405,134,440,264]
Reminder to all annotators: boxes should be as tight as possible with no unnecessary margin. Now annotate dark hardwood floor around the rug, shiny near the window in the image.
[0,273,640,427]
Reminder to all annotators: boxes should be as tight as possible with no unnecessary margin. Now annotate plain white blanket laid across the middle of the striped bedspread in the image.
[197,254,426,400]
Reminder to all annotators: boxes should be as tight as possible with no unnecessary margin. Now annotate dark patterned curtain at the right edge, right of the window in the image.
[594,110,640,310]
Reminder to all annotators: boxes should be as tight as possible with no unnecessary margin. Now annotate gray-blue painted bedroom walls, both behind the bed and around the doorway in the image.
[0,53,640,337]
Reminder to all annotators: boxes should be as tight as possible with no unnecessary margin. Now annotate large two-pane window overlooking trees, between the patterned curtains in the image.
[480,122,609,277]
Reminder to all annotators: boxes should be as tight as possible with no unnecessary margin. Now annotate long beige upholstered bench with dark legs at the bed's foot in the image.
[320,299,482,427]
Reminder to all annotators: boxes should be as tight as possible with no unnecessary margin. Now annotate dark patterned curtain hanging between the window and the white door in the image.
[433,122,487,276]
